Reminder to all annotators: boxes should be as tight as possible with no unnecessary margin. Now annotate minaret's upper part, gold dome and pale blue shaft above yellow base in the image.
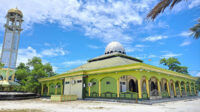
[1,8,23,69]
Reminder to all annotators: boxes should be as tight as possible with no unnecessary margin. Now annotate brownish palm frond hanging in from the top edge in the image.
[147,0,182,20]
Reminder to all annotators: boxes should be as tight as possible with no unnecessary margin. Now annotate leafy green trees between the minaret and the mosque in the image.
[15,57,55,93]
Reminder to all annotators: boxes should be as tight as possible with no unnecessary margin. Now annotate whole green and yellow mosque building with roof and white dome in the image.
[39,42,196,100]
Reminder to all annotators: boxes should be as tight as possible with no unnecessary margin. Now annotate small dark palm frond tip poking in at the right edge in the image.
[190,19,200,39]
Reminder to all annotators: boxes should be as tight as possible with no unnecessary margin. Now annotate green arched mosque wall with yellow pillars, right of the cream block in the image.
[86,70,195,98]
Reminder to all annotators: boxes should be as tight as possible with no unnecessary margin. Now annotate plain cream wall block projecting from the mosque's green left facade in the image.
[64,76,83,99]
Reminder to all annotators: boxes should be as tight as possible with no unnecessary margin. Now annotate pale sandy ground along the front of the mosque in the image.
[0,99,200,112]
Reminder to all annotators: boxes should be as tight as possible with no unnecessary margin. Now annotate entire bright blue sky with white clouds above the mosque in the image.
[0,0,200,76]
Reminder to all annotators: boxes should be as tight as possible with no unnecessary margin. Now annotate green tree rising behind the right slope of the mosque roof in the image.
[160,57,188,74]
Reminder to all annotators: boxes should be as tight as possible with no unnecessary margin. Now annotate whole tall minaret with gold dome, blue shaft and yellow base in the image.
[0,8,23,91]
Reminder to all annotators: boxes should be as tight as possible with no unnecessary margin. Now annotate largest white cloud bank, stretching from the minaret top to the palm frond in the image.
[0,0,156,42]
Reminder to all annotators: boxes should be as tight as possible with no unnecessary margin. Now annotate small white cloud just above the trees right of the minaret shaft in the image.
[41,48,68,57]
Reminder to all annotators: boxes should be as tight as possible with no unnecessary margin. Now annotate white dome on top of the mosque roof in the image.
[105,42,126,54]
